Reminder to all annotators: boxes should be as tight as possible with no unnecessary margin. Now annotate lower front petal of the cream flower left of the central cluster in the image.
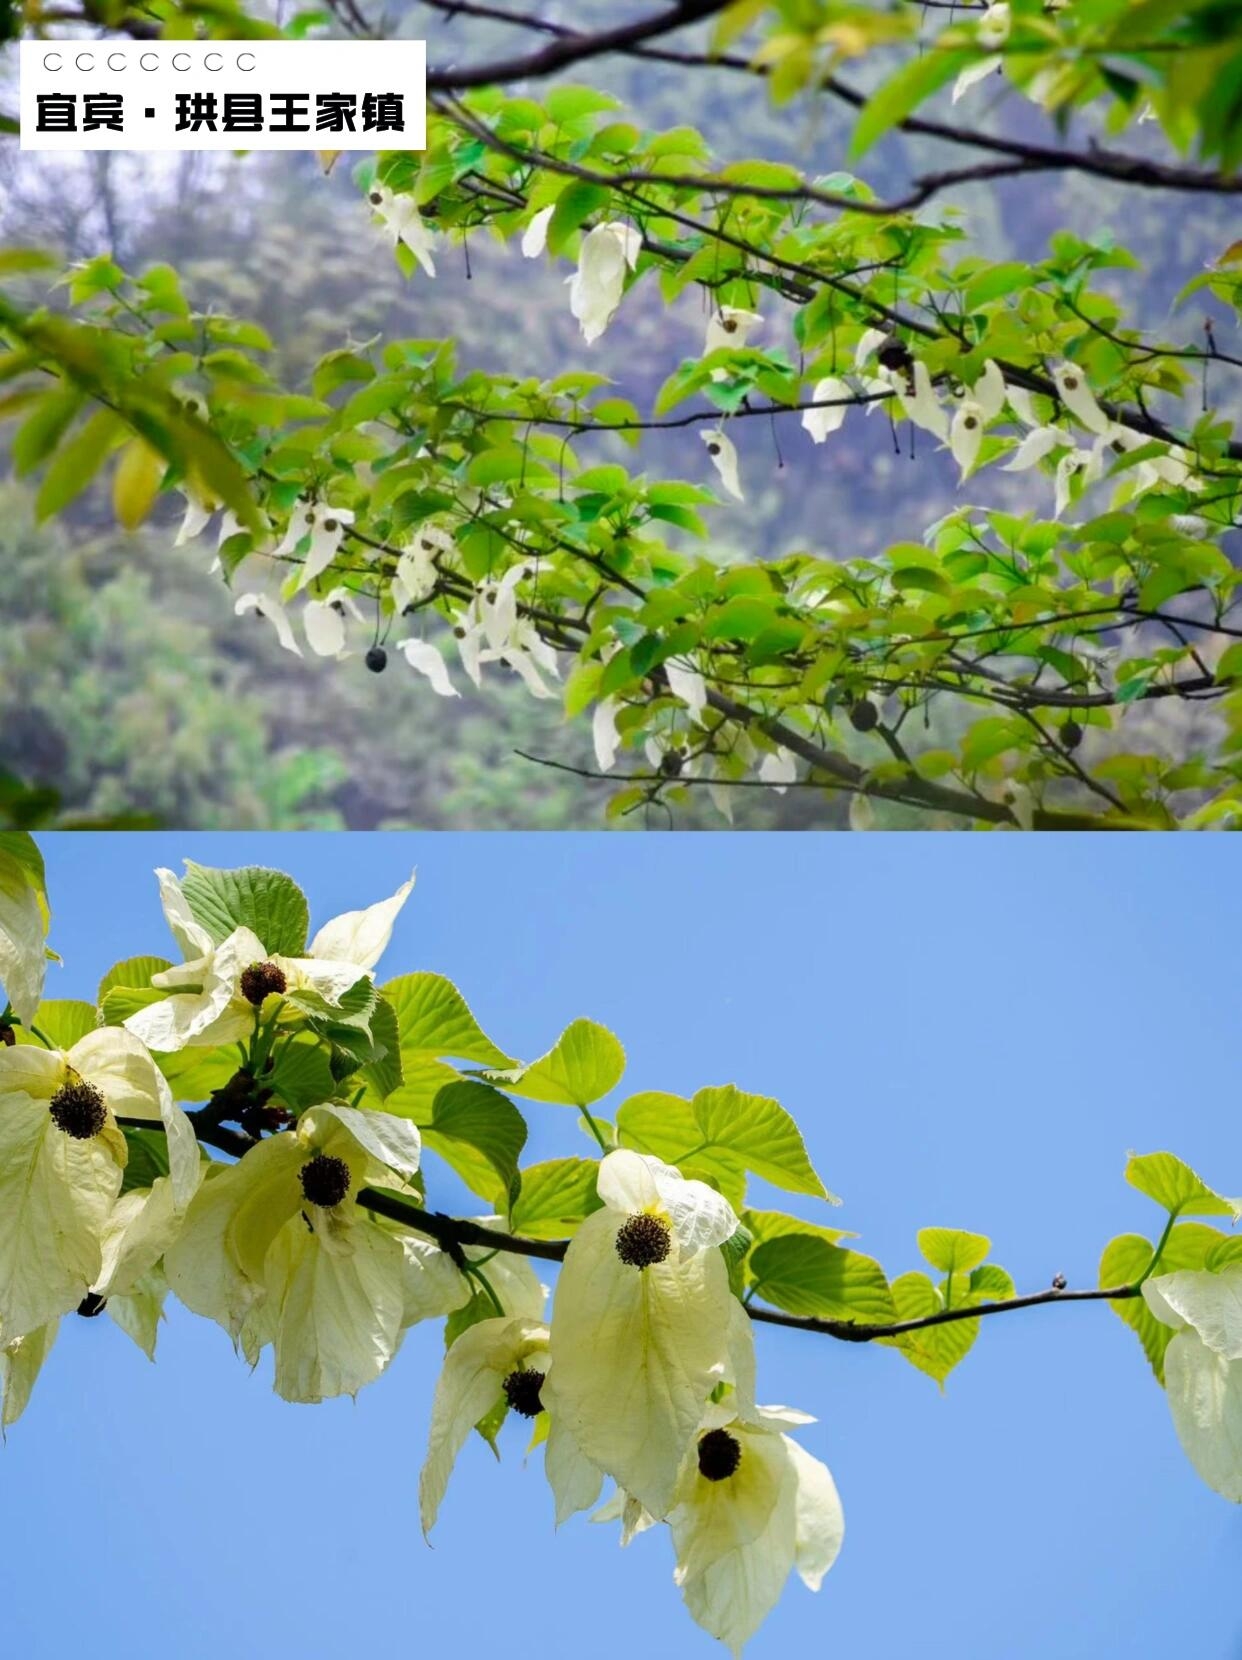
[264,1215,405,1401]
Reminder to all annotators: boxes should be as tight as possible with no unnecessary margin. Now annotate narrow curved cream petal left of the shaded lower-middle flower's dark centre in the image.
[418,1320,546,1534]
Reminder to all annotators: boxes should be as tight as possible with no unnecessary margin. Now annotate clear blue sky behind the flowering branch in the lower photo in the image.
[0,833,1242,1660]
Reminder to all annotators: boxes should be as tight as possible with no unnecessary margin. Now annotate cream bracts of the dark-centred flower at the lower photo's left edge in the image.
[0,1026,199,1343]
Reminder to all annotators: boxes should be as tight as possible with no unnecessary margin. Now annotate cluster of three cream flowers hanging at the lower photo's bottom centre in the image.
[420,1149,843,1653]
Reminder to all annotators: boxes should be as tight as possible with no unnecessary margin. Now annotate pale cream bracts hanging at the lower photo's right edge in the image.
[1142,1263,1242,1504]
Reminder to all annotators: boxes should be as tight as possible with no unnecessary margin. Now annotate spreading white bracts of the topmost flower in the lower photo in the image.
[125,870,413,1054]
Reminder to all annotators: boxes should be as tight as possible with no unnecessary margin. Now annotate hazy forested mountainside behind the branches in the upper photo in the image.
[0,0,1237,828]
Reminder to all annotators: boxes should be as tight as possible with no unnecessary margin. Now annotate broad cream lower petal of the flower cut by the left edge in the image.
[0,1096,125,1341]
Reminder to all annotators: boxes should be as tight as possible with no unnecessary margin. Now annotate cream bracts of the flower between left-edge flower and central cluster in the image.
[164,1104,444,1401]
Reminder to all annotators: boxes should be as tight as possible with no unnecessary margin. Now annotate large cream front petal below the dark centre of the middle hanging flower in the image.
[545,1208,731,1516]
